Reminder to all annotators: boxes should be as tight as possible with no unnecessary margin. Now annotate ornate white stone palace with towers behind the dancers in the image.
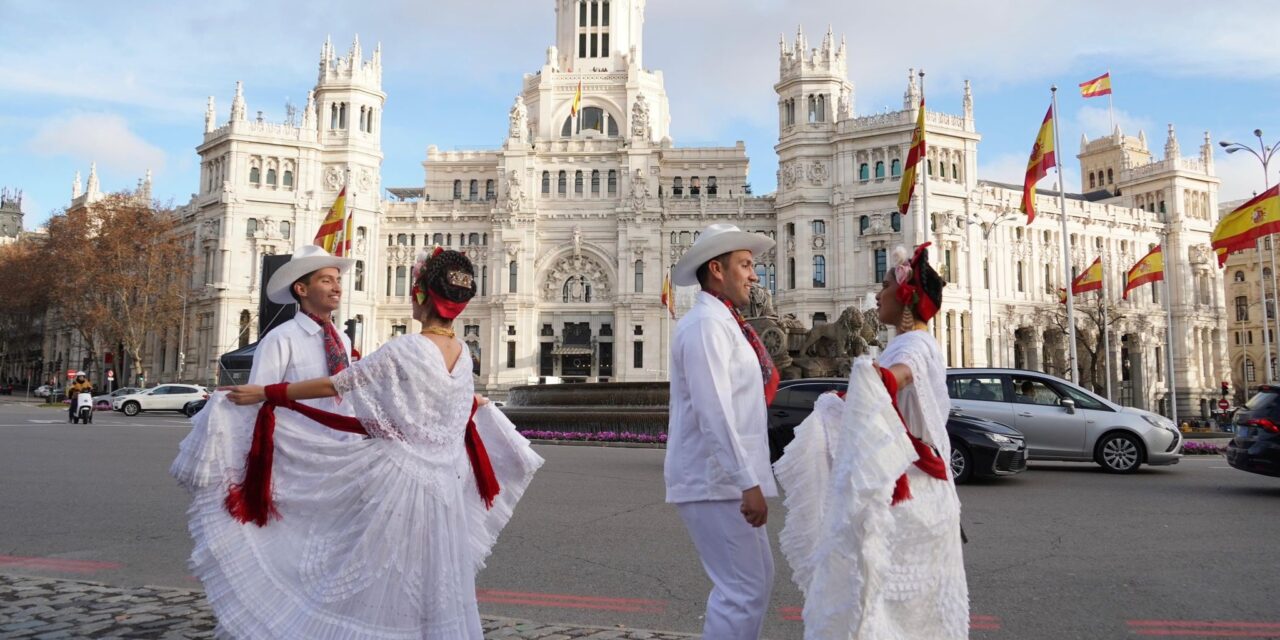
[60,0,1228,415]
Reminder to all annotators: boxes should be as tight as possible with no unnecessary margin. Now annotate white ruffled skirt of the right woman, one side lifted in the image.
[774,358,969,640]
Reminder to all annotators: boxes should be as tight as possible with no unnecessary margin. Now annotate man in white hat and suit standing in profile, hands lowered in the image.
[664,224,778,640]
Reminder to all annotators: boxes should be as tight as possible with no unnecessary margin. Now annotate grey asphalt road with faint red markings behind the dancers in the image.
[0,404,1280,639]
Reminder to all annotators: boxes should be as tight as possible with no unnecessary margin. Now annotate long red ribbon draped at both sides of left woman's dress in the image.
[223,383,500,526]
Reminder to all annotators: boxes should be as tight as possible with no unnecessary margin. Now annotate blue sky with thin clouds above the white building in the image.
[0,0,1280,228]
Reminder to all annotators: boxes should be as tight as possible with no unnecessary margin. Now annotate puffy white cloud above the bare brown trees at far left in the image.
[27,114,165,175]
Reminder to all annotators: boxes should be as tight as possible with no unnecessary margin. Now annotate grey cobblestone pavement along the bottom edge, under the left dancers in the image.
[0,575,696,640]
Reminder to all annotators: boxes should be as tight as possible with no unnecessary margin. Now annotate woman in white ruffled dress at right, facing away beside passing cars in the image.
[774,244,969,640]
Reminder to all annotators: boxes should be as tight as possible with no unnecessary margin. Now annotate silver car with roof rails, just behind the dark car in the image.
[947,369,1183,474]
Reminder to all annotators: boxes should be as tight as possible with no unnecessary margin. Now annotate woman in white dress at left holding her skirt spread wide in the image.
[172,250,543,640]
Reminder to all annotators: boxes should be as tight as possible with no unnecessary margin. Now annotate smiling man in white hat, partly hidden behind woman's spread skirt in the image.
[248,244,360,440]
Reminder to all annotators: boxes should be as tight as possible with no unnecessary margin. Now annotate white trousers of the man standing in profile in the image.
[677,500,773,640]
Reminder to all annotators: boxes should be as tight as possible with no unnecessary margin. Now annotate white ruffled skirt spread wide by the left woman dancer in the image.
[170,394,543,640]
